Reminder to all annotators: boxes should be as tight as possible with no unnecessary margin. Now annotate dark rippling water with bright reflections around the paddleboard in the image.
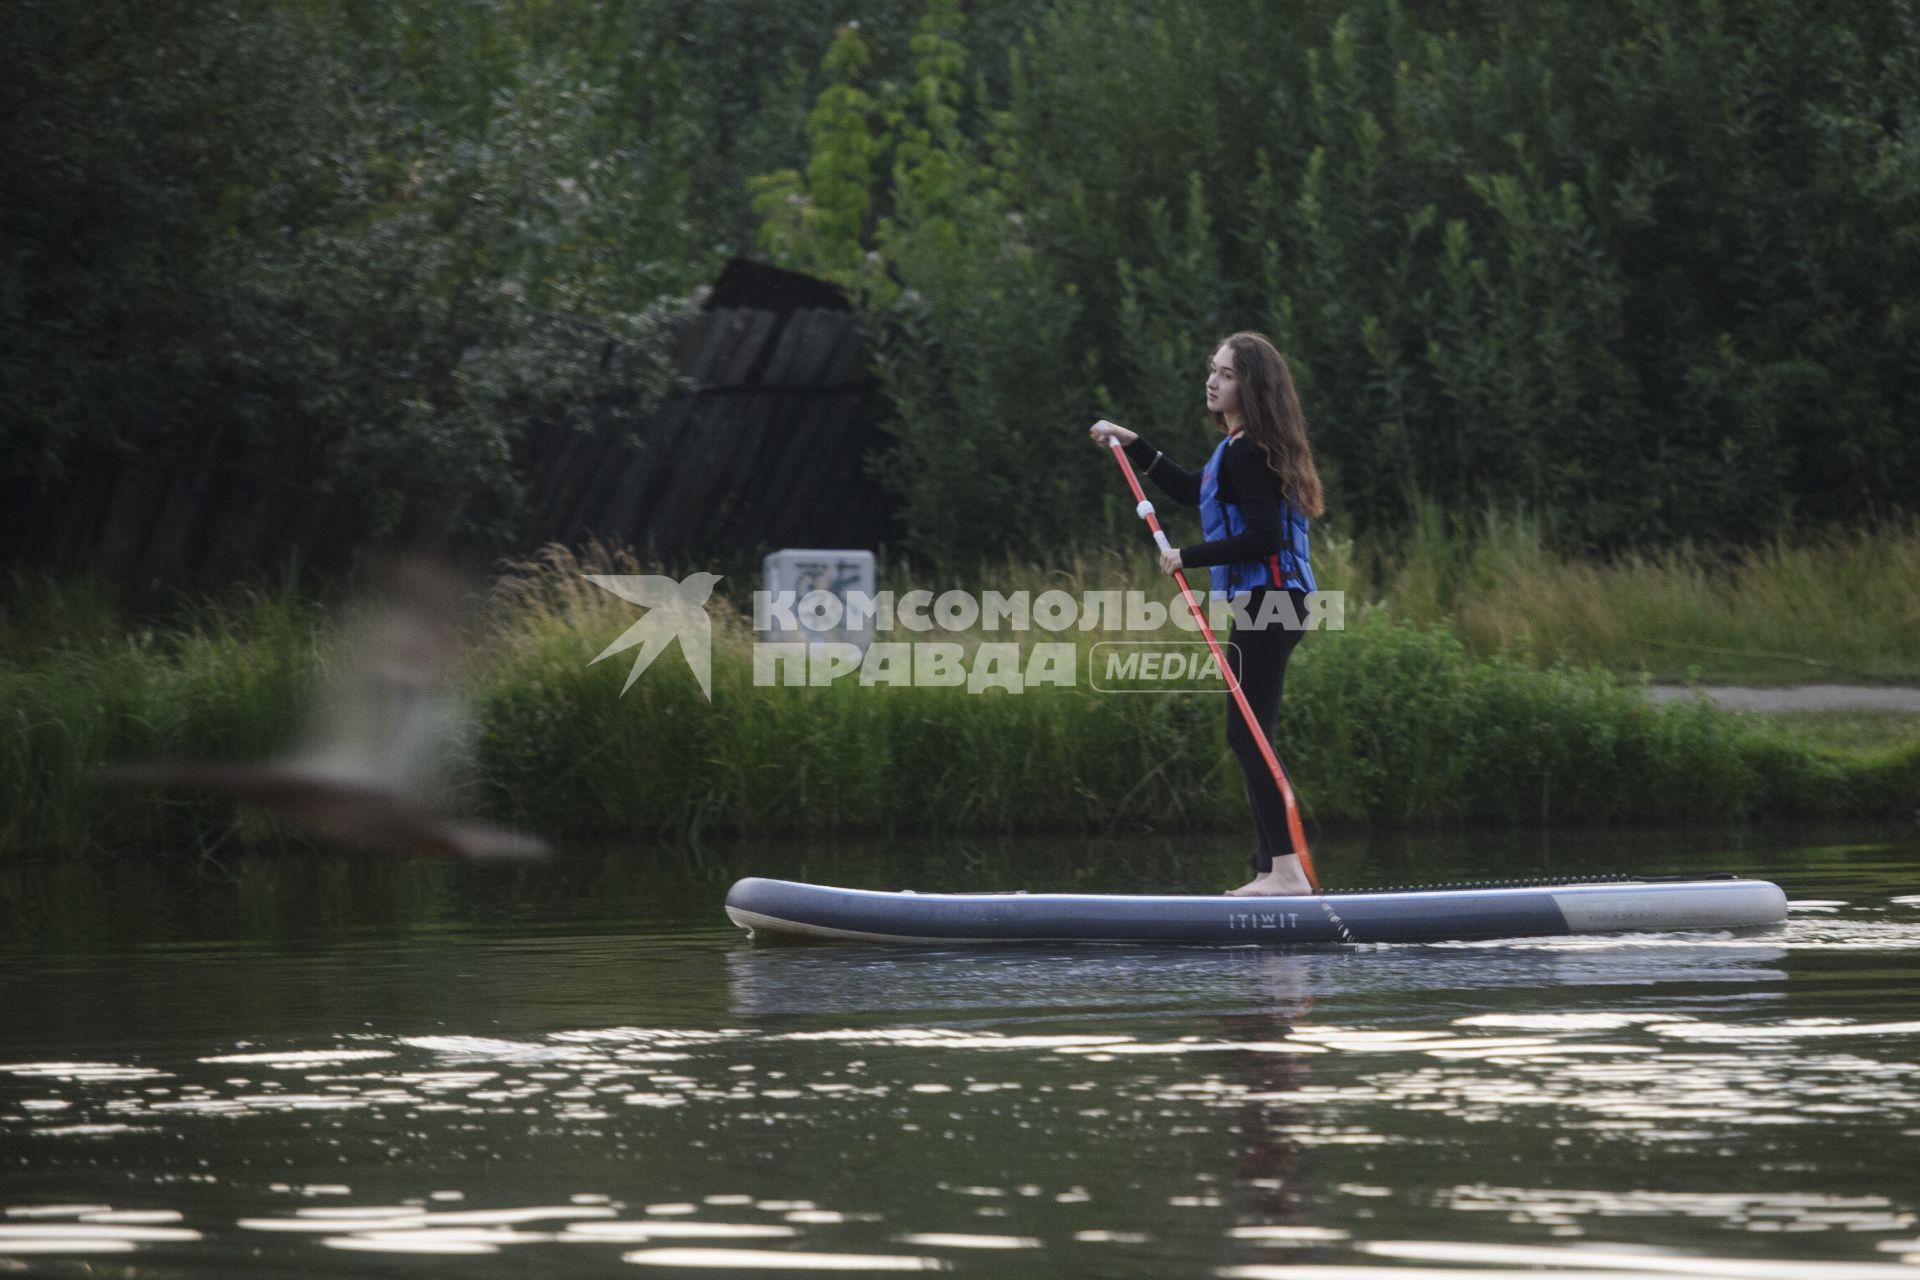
[0,829,1920,1280]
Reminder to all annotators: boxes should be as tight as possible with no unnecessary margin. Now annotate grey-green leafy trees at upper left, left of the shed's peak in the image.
[0,0,898,537]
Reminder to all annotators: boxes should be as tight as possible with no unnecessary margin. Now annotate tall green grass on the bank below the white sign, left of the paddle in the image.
[480,553,1217,839]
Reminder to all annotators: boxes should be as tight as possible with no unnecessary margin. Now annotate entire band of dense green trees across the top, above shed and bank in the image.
[0,0,1920,557]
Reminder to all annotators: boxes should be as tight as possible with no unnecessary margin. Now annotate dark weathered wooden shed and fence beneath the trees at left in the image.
[0,259,893,585]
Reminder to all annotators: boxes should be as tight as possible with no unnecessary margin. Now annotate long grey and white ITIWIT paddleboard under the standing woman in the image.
[726,875,1788,946]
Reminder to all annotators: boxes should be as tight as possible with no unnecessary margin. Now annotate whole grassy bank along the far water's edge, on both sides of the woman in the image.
[0,557,1920,854]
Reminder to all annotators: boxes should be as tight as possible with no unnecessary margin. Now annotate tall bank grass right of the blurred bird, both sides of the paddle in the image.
[456,549,1920,839]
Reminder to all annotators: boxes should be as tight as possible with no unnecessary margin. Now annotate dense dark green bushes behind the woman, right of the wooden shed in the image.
[770,0,1920,557]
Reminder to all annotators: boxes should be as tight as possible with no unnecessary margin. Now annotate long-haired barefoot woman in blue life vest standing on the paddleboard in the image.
[1092,332,1323,896]
